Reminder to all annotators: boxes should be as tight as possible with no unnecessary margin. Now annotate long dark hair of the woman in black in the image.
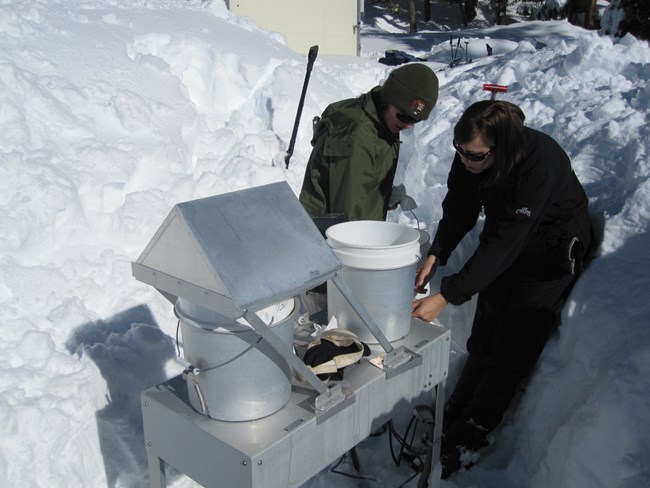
[454,100,526,186]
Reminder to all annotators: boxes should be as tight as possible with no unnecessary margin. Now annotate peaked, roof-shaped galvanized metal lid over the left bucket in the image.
[132,182,341,318]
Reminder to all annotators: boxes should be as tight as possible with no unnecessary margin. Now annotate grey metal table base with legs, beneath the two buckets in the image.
[142,320,450,488]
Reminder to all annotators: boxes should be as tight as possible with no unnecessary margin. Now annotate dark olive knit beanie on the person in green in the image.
[381,63,438,120]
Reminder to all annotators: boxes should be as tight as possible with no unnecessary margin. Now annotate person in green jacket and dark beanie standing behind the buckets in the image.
[300,63,438,220]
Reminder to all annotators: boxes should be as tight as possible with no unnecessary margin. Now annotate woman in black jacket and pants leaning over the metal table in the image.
[413,100,594,478]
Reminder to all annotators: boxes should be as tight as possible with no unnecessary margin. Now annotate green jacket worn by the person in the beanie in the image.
[300,86,400,220]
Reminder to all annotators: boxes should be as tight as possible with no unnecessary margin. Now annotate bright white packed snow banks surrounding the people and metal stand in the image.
[0,0,650,488]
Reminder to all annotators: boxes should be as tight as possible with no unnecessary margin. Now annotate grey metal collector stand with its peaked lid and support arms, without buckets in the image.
[132,182,450,488]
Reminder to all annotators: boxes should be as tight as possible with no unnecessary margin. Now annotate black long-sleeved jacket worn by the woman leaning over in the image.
[429,128,593,305]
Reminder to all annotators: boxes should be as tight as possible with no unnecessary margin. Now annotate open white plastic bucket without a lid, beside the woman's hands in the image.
[326,220,420,344]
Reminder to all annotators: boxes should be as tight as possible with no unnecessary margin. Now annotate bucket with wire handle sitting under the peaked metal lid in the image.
[174,298,298,421]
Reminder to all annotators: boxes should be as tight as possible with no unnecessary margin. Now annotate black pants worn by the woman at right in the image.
[444,266,576,449]
